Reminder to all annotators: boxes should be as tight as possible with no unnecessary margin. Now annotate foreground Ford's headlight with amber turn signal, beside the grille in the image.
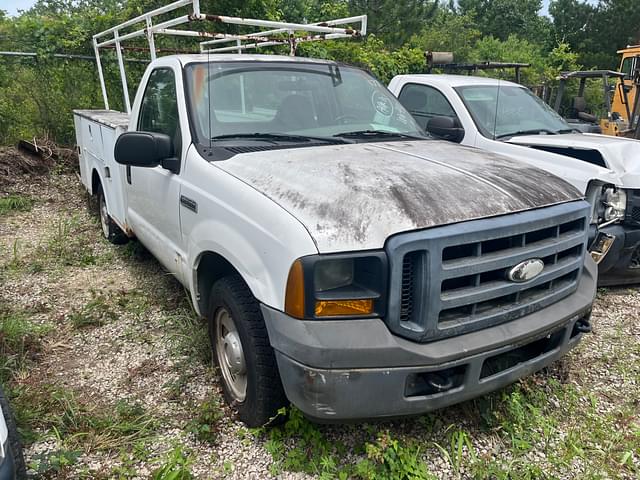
[285,252,387,319]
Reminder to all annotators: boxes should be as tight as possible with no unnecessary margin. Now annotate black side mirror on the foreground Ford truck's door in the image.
[114,132,173,167]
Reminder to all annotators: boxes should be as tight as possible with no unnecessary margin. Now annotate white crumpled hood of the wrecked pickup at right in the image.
[509,133,640,188]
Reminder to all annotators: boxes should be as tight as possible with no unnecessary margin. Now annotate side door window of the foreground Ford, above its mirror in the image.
[138,68,182,154]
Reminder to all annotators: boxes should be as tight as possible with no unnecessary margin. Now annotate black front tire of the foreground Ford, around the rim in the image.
[208,275,288,427]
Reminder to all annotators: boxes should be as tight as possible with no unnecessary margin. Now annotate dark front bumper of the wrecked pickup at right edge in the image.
[598,224,640,287]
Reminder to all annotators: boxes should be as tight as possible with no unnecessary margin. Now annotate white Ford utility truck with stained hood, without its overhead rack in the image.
[75,54,596,426]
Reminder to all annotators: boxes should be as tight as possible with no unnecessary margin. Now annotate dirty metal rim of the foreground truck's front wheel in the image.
[214,308,247,402]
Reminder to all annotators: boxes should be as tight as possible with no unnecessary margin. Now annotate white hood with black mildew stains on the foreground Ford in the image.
[215,141,582,253]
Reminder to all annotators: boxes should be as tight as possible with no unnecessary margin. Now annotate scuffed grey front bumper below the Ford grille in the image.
[262,261,596,421]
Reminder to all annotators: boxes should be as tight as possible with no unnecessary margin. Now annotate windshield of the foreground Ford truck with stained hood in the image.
[186,62,424,144]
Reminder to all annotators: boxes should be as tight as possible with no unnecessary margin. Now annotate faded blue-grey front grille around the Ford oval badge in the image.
[387,201,590,342]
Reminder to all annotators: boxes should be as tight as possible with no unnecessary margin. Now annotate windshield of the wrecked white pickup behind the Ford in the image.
[455,85,572,138]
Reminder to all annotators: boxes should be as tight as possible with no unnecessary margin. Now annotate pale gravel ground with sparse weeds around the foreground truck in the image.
[0,174,640,479]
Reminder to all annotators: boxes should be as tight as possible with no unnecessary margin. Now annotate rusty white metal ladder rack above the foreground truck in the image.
[93,0,367,113]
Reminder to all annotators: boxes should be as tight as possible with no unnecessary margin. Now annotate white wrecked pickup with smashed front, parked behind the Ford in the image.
[389,74,640,285]
